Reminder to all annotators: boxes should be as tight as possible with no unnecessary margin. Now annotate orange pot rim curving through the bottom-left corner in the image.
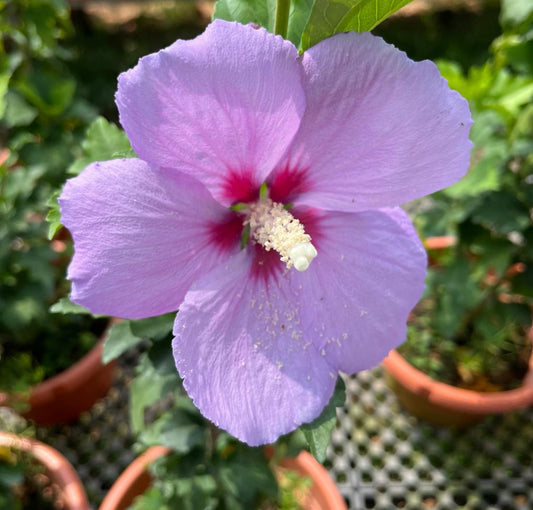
[0,432,89,510]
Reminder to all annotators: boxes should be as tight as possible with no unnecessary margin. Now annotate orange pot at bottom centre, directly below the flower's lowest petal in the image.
[99,446,346,510]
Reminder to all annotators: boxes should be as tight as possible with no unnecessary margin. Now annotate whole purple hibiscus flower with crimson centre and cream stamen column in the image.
[60,21,471,445]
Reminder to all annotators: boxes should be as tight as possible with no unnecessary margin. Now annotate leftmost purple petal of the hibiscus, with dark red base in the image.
[59,159,239,318]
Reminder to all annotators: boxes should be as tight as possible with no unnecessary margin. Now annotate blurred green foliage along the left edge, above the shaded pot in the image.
[0,0,105,392]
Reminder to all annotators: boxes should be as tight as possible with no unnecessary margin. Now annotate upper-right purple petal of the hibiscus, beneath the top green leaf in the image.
[271,32,472,211]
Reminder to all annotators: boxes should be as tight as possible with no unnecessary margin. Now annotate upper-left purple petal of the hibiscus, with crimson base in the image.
[116,20,305,205]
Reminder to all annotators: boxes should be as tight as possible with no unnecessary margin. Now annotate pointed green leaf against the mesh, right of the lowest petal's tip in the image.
[300,377,346,462]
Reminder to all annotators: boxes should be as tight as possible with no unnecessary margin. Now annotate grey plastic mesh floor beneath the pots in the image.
[37,355,533,510]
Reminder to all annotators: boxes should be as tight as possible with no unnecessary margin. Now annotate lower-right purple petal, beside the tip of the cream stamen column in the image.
[292,208,426,373]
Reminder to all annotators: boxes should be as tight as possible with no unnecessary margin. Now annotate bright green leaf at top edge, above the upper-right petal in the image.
[301,0,411,50]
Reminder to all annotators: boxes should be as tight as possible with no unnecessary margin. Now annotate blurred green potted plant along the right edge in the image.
[399,0,533,391]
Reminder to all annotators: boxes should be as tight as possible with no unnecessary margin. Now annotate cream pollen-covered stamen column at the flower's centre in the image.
[248,198,317,271]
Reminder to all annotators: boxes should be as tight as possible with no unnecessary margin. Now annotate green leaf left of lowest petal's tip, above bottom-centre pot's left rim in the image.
[139,409,207,454]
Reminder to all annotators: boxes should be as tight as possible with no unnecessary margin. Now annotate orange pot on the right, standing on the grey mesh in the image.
[382,338,533,427]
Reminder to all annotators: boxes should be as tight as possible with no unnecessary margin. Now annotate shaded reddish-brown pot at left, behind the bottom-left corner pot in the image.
[0,320,116,425]
